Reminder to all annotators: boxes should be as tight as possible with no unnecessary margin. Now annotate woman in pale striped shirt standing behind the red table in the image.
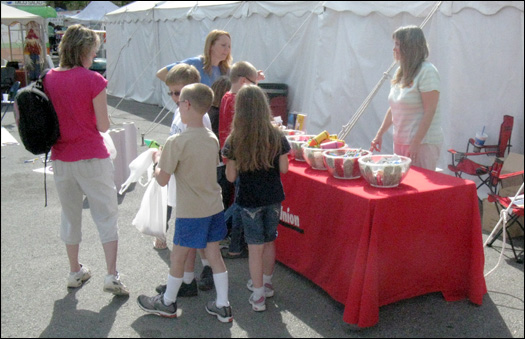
[370,26,443,170]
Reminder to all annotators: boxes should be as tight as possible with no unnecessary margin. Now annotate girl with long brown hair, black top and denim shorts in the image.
[222,85,290,311]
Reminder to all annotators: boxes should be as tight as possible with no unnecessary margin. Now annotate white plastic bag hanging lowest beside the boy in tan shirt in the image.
[131,179,168,241]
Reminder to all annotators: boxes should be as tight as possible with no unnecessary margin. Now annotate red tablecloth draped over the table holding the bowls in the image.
[276,161,487,327]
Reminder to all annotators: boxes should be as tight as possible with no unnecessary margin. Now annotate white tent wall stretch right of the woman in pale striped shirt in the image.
[430,7,524,170]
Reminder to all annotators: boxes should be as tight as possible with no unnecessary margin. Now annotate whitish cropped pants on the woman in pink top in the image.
[53,158,118,245]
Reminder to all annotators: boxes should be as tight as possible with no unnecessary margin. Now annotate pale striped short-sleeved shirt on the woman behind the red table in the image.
[388,61,443,145]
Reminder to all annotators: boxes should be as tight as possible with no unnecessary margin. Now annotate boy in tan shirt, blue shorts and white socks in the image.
[137,84,233,322]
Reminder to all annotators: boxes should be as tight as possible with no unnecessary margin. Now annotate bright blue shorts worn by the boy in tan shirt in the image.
[173,211,227,248]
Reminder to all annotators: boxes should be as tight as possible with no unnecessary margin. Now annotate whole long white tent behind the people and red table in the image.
[106,1,524,174]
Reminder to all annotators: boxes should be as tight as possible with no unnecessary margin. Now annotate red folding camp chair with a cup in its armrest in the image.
[448,115,514,194]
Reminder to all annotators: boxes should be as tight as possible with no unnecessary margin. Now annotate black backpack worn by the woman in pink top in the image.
[14,69,60,206]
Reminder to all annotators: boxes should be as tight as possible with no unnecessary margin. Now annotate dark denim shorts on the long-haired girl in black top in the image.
[239,203,281,245]
